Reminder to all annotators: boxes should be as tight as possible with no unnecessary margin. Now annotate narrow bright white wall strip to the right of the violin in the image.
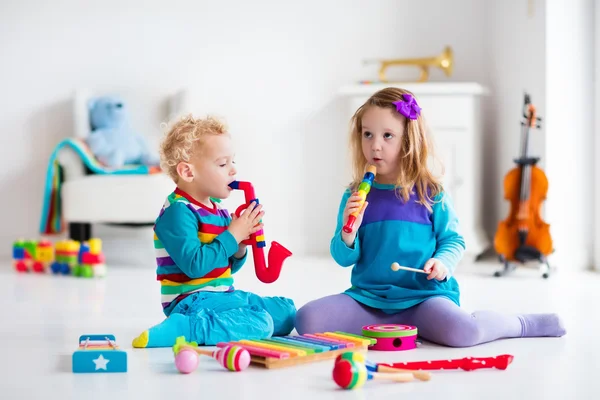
[546,0,595,269]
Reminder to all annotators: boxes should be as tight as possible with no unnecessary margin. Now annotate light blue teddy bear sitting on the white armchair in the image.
[86,96,160,168]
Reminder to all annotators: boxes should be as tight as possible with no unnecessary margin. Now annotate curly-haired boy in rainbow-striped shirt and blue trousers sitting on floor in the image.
[133,116,296,347]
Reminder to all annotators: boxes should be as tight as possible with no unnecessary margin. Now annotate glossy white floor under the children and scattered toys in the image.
[0,257,600,400]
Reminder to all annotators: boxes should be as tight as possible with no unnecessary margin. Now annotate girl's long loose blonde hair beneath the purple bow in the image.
[350,87,443,211]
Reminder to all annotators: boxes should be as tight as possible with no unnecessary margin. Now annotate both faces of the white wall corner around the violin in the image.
[485,0,594,270]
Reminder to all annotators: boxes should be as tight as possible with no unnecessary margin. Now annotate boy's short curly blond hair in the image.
[160,114,228,183]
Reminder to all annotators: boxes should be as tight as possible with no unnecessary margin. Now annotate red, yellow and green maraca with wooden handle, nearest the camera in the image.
[332,359,414,389]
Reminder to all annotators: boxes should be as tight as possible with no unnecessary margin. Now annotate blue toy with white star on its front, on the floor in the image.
[73,335,127,373]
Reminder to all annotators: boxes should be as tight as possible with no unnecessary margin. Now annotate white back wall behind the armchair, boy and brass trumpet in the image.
[0,0,485,260]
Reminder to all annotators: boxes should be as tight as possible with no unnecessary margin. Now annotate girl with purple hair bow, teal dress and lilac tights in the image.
[296,88,566,347]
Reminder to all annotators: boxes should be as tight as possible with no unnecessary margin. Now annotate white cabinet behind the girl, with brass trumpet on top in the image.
[340,82,490,257]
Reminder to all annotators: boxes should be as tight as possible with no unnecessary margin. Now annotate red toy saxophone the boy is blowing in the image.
[229,181,292,283]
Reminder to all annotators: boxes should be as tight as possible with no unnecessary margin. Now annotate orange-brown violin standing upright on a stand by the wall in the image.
[494,93,554,278]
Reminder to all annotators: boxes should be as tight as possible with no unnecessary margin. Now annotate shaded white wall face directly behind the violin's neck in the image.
[484,0,547,250]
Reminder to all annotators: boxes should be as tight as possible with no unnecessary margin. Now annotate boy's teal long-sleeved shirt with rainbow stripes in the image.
[154,193,243,315]
